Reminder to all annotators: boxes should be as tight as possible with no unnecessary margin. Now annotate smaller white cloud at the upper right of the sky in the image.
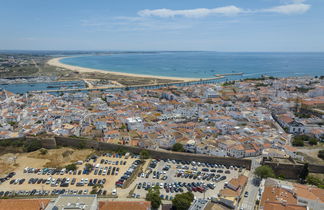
[260,3,311,15]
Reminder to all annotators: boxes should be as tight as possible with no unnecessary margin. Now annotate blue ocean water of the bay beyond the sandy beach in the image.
[61,52,324,78]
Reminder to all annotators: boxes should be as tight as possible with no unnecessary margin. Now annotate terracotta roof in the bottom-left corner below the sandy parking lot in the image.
[0,199,50,210]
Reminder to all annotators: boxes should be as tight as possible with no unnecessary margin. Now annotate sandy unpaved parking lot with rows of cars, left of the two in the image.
[0,153,138,197]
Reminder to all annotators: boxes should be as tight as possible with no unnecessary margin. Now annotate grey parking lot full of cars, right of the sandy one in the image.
[132,160,244,200]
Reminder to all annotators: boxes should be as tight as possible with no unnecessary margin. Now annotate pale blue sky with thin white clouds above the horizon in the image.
[0,0,324,52]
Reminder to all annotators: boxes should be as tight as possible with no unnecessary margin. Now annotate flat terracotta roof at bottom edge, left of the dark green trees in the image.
[99,201,151,210]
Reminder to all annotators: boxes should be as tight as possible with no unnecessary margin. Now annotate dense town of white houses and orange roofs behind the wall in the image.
[0,78,324,160]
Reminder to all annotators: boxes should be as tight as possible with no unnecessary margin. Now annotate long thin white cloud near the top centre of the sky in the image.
[138,6,243,18]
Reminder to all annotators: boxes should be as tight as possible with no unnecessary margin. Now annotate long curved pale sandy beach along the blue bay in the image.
[47,57,201,82]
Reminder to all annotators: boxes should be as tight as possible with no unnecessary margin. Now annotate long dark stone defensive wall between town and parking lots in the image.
[4,137,324,174]
